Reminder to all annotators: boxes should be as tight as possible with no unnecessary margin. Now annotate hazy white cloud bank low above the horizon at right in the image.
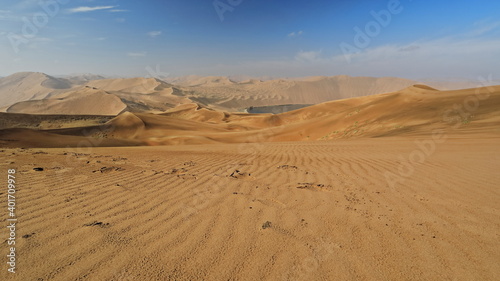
[192,37,500,80]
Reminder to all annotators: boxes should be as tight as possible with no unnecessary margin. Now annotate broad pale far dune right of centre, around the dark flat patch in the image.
[172,76,416,111]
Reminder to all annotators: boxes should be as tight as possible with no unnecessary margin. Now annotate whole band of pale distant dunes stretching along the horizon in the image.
[0,72,496,115]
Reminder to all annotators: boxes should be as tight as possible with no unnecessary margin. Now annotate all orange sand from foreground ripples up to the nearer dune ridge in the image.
[0,82,500,281]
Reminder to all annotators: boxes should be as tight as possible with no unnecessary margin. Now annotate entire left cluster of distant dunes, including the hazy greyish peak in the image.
[0,72,188,115]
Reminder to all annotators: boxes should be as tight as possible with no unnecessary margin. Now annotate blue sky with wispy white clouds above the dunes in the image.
[0,0,500,79]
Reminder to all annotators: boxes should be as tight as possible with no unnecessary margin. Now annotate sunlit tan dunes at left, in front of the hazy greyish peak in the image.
[4,76,192,115]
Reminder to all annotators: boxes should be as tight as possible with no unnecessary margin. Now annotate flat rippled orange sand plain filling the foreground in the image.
[0,135,500,280]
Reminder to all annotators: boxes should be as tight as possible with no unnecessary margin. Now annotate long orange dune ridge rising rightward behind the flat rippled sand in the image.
[3,85,500,146]
